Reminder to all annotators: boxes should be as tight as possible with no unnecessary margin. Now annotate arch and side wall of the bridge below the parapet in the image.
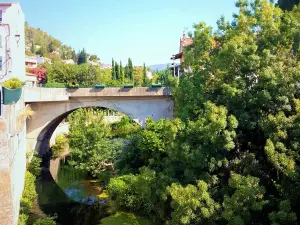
[27,91,173,154]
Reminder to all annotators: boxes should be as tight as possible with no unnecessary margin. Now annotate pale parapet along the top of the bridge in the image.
[24,87,171,102]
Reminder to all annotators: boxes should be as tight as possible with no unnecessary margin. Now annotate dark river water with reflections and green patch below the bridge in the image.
[31,160,150,225]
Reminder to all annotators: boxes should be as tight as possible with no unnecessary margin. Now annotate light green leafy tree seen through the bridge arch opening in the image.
[68,108,117,176]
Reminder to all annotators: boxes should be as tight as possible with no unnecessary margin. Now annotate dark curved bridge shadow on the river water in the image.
[36,155,108,225]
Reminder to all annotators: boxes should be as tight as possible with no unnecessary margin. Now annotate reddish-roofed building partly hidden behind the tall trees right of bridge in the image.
[170,33,193,76]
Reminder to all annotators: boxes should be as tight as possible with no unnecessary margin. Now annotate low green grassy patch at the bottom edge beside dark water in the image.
[99,212,151,225]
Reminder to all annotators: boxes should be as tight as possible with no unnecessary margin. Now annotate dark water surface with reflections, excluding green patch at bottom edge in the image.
[36,158,108,225]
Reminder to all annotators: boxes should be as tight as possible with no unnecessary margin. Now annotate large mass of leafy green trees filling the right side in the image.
[108,0,300,225]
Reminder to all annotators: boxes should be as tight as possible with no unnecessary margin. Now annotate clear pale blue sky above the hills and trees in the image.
[15,0,236,65]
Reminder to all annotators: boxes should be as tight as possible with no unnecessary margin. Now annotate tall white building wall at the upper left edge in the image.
[0,3,26,83]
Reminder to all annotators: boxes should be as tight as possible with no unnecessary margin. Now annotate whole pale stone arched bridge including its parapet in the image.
[24,88,173,155]
